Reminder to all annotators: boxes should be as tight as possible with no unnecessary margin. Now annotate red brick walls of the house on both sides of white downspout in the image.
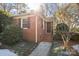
[14,15,52,42]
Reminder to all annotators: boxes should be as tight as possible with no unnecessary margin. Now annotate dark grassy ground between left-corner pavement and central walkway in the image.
[1,41,37,56]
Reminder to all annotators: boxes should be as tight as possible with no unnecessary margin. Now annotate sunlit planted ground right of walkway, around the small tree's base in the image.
[49,41,79,56]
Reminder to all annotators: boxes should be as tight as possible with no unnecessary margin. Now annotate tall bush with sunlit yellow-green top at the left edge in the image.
[0,10,12,33]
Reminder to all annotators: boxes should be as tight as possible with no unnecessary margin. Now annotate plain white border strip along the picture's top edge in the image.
[0,0,79,3]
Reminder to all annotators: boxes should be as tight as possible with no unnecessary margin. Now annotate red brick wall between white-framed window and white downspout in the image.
[23,16,35,41]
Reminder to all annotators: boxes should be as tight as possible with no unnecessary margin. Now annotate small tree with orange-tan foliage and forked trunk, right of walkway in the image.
[55,4,79,48]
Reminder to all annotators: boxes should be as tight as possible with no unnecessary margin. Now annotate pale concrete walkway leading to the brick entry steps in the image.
[29,42,52,56]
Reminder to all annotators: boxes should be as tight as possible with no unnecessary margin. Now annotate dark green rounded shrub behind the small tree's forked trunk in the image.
[56,23,69,39]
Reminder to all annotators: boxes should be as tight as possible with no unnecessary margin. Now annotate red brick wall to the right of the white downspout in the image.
[37,17,53,42]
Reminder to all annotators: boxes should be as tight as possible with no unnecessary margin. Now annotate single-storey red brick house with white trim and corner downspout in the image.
[13,13,53,42]
